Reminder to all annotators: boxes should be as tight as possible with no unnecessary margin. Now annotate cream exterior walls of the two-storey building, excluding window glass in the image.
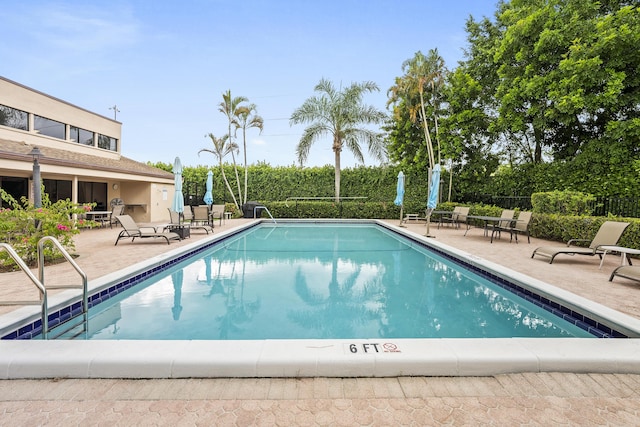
[0,77,174,222]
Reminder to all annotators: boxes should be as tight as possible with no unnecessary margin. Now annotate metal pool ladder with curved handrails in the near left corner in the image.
[0,236,89,340]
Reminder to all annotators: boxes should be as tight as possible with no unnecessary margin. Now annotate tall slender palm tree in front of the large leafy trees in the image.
[388,49,445,169]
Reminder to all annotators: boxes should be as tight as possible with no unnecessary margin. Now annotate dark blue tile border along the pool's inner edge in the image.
[0,221,628,340]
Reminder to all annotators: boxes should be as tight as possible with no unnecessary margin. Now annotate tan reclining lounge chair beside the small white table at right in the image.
[531,221,629,264]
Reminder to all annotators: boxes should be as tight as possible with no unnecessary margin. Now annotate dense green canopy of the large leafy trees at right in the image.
[389,0,640,195]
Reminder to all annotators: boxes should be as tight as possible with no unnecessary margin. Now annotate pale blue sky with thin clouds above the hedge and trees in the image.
[0,0,497,168]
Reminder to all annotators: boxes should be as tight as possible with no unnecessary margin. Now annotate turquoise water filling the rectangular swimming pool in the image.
[74,224,593,340]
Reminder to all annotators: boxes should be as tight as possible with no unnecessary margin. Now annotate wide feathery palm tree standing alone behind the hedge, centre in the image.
[289,79,386,202]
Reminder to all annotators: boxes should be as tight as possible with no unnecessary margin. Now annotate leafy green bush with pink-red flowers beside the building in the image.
[0,188,96,270]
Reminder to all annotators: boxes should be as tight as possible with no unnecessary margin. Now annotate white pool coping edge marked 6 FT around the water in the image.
[0,219,640,379]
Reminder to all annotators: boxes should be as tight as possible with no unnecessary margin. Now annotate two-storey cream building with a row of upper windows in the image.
[0,76,174,222]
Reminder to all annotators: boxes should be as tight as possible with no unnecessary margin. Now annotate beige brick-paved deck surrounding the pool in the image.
[0,219,640,425]
